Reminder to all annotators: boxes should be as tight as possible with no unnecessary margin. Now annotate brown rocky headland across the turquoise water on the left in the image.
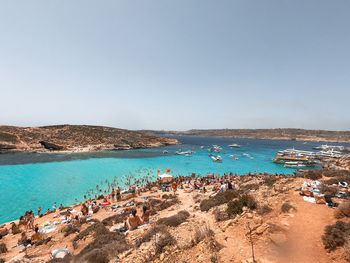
[0,125,179,153]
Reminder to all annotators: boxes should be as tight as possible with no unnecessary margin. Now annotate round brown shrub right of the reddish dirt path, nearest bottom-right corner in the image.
[322,221,350,251]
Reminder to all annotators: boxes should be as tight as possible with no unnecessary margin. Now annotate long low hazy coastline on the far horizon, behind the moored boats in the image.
[140,129,350,143]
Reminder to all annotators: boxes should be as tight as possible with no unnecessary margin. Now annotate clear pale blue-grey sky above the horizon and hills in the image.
[0,0,350,130]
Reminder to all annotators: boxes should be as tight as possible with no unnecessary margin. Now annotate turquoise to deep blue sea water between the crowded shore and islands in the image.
[0,136,346,223]
